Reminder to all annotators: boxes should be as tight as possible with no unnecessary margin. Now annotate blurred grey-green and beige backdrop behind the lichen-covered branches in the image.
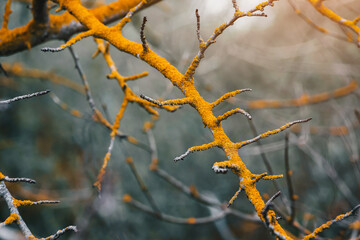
[0,0,360,240]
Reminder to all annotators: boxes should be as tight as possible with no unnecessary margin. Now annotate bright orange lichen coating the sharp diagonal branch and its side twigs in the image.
[39,0,310,239]
